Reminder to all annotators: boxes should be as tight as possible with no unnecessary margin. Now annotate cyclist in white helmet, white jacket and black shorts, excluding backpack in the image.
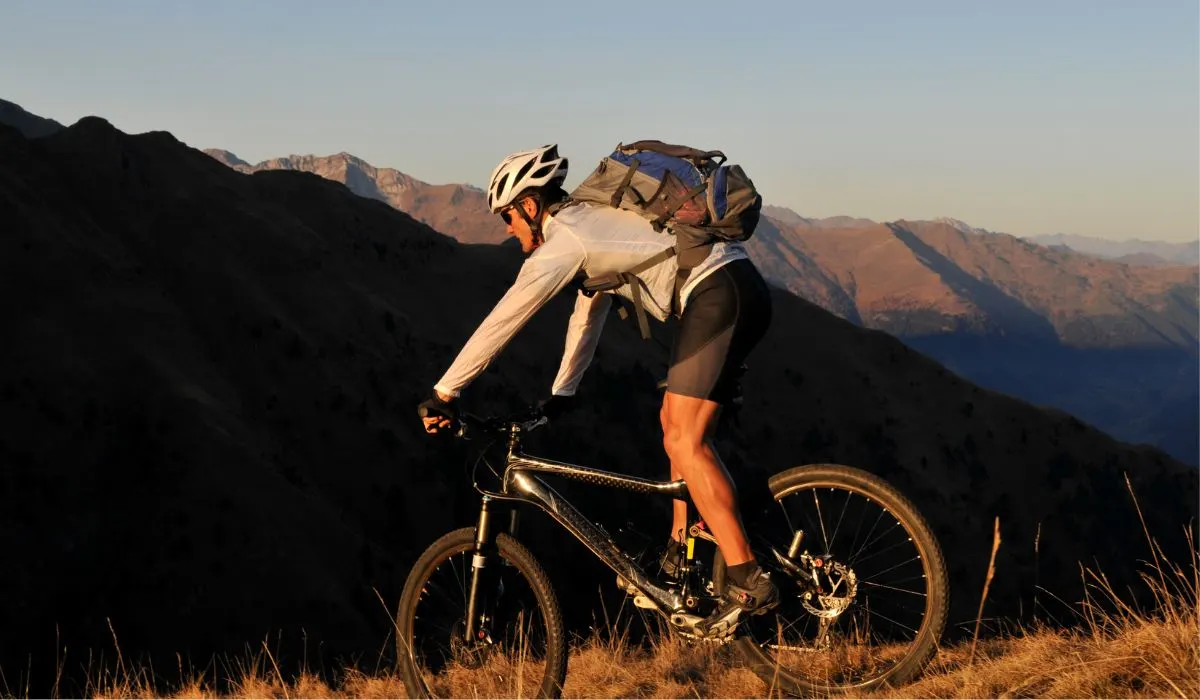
[421,144,779,629]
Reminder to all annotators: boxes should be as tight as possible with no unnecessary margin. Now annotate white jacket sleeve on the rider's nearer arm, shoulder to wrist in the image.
[433,232,584,396]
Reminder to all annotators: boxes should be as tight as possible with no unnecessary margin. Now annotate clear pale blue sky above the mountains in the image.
[0,0,1200,240]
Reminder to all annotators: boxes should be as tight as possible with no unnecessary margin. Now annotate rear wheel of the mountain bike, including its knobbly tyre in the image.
[714,465,949,695]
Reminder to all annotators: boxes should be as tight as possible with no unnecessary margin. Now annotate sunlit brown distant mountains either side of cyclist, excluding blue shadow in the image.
[205,149,1198,352]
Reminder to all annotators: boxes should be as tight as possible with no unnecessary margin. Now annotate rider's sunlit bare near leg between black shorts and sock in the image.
[660,391,754,567]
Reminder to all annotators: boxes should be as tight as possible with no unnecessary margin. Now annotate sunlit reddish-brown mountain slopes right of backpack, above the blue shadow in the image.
[746,210,1200,354]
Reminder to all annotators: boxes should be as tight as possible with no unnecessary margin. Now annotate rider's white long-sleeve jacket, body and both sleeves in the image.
[434,204,746,396]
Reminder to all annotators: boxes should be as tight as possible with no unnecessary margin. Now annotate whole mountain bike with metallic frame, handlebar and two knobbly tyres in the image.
[412,414,948,693]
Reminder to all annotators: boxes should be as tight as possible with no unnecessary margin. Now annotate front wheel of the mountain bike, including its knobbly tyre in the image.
[396,527,566,698]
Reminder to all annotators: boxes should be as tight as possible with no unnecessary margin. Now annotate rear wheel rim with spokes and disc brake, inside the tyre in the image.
[748,483,934,687]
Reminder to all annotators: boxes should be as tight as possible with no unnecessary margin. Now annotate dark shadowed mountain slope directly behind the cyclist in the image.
[0,106,1200,695]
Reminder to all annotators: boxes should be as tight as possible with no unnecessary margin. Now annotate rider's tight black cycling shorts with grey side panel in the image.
[667,258,770,405]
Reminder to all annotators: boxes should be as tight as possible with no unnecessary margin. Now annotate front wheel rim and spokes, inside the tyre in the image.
[402,545,548,698]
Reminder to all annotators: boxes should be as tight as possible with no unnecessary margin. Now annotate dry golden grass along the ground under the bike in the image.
[18,489,1200,699]
